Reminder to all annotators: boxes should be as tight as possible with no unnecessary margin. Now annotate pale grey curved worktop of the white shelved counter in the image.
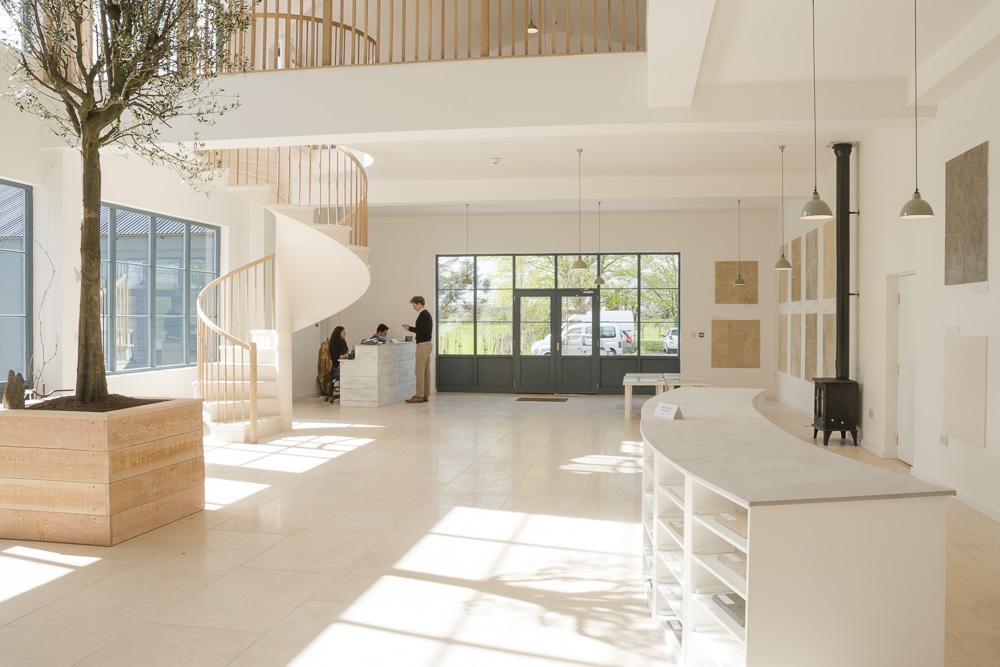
[641,387,955,507]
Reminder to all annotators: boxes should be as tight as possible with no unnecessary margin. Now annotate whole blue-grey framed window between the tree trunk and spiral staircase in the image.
[101,204,221,374]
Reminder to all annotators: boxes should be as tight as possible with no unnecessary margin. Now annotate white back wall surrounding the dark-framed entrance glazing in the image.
[338,209,778,388]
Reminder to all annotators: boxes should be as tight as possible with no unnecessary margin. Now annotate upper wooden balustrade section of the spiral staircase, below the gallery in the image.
[201,145,368,247]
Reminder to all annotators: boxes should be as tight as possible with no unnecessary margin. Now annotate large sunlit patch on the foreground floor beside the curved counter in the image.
[290,507,662,667]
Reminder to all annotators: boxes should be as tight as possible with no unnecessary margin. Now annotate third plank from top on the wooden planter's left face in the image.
[0,477,108,514]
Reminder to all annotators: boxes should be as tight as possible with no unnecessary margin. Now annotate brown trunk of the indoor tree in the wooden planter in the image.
[76,133,114,403]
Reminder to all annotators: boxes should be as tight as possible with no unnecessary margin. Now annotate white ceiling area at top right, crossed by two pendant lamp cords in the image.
[699,0,991,85]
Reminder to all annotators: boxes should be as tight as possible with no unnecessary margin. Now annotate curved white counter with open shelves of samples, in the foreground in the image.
[641,388,954,667]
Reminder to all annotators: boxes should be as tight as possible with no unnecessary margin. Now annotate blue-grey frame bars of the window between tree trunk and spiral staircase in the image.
[101,202,222,375]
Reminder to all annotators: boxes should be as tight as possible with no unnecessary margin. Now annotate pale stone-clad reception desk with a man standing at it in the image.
[340,343,417,408]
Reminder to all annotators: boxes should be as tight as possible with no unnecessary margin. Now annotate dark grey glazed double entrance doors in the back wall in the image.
[514,290,599,394]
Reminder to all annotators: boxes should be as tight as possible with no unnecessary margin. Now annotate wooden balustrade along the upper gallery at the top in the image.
[223,0,646,71]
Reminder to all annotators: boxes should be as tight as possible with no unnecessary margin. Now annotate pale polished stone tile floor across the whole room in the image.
[0,395,1000,667]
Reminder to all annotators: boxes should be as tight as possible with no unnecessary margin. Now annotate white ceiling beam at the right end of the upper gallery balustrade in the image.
[646,0,715,107]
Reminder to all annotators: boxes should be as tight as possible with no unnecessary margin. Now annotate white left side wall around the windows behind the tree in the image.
[0,103,274,396]
